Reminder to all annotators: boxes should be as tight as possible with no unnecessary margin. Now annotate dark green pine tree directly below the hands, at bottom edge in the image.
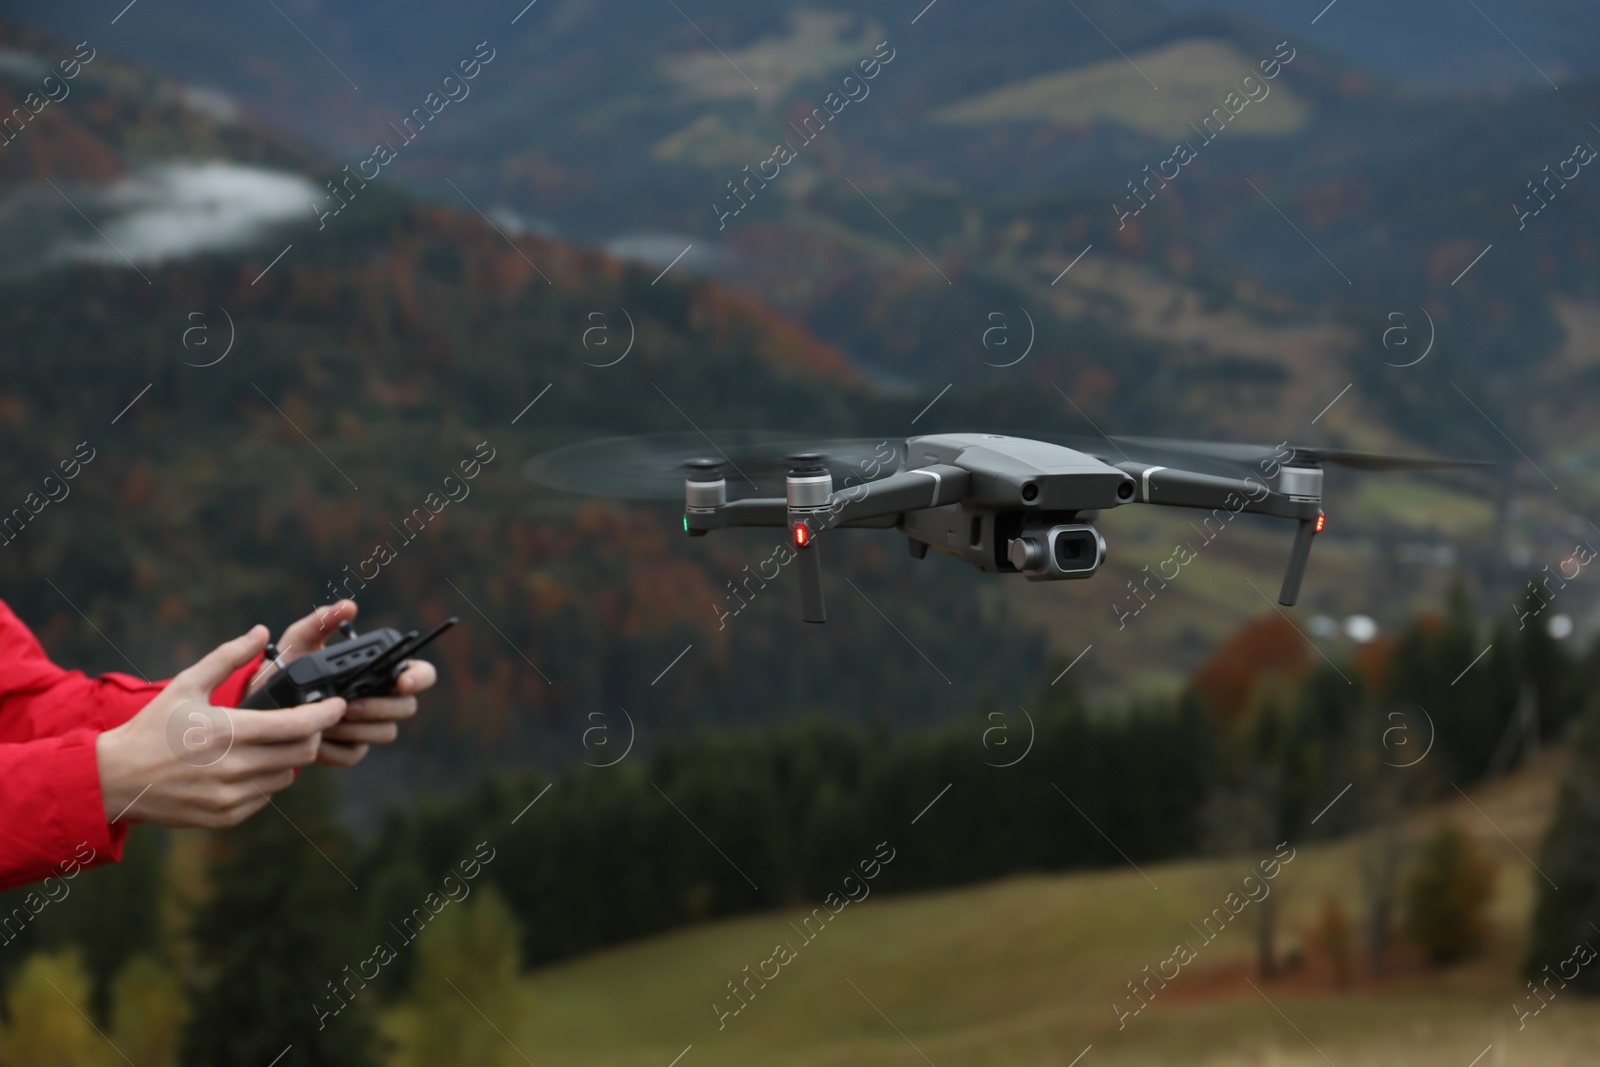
[182,768,376,1067]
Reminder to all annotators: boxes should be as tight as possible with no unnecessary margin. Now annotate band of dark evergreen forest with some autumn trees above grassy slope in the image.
[0,584,1600,1065]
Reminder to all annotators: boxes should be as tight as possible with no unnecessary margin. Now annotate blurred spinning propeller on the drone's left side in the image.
[522,430,906,501]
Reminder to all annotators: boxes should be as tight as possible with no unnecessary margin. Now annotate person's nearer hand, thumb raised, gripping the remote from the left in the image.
[94,625,346,829]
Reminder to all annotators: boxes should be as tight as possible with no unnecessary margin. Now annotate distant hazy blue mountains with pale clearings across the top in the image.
[12,0,1600,467]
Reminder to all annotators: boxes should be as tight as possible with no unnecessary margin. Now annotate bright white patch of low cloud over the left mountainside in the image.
[50,162,322,267]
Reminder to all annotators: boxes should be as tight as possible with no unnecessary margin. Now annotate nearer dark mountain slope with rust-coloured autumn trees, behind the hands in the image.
[0,20,1043,812]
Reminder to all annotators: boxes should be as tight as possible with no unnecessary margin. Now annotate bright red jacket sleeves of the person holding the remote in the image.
[0,601,256,889]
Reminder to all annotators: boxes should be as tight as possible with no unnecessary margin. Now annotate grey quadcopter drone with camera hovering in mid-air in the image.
[525,434,1486,622]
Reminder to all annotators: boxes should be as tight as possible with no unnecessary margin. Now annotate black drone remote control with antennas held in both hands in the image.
[240,616,459,710]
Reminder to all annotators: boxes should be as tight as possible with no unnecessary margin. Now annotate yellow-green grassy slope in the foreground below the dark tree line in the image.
[451,755,1600,1067]
